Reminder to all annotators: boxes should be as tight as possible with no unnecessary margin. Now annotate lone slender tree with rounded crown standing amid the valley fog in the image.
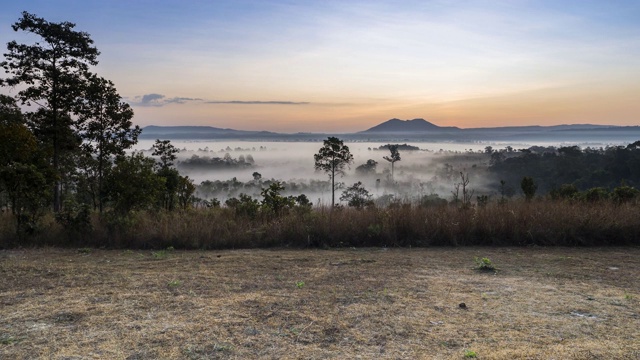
[313,136,353,206]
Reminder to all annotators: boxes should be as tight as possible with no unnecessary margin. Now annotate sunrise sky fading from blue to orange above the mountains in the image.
[0,0,640,133]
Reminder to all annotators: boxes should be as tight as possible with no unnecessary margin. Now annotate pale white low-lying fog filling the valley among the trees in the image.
[135,140,622,204]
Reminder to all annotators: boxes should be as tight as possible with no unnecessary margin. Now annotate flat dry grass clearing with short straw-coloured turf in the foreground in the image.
[0,247,640,359]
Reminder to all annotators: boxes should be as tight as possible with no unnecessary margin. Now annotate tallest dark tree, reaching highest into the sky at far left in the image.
[0,11,100,211]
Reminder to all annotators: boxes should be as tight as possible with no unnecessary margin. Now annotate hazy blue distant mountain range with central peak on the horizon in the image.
[140,119,640,142]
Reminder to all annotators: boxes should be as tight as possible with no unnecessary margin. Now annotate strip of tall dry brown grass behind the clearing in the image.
[0,200,640,249]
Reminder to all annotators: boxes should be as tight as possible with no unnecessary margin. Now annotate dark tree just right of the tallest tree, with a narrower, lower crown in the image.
[79,74,142,212]
